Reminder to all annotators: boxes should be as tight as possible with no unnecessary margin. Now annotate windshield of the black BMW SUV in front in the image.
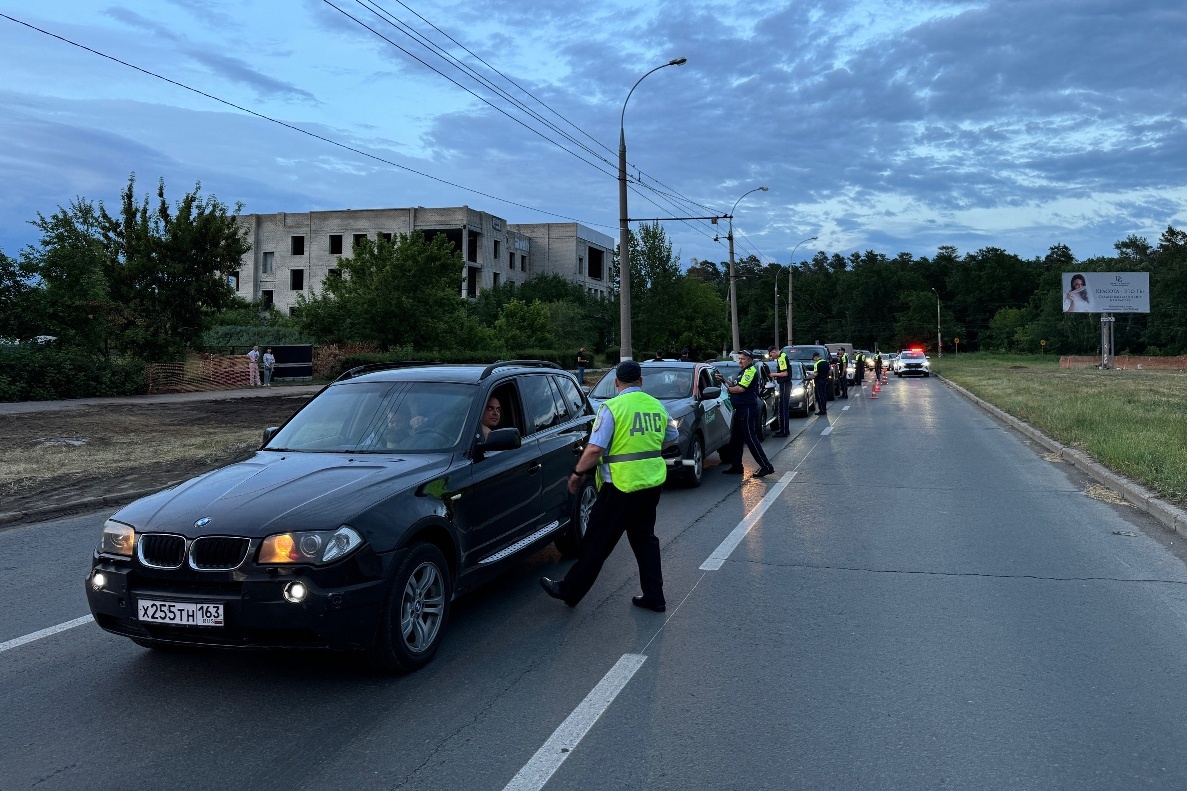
[265,382,477,454]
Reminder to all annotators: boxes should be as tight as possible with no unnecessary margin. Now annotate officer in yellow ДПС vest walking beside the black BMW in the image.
[540,360,679,613]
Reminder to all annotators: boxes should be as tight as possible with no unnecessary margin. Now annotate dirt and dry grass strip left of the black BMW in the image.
[0,391,311,514]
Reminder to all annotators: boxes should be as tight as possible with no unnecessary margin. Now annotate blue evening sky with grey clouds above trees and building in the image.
[0,0,1187,264]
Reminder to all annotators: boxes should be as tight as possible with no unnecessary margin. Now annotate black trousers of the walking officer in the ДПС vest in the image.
[560,483,665,605]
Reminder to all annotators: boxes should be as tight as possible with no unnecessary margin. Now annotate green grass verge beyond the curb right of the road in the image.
[932,354,1187,507]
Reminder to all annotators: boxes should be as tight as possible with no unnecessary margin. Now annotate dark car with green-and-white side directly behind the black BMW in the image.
[590,360,734,487]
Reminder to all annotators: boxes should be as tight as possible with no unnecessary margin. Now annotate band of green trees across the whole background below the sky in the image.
[0,175,1187,398]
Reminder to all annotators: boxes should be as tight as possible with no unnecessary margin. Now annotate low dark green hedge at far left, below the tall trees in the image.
[0,346,147,401]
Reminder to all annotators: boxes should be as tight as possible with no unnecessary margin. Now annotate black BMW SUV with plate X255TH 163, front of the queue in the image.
[85,361,597,671]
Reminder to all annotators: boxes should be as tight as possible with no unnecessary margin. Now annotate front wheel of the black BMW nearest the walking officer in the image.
[368,544,452,673]
